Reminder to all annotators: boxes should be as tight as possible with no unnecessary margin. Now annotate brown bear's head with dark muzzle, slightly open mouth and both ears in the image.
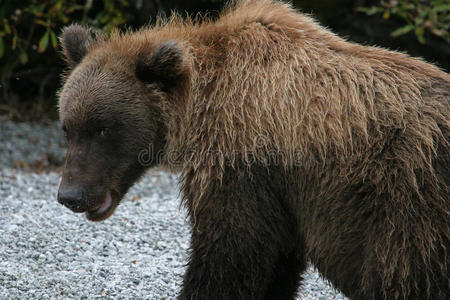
[58,25,189,221]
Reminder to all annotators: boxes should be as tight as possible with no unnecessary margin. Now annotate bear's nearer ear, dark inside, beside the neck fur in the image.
[136,41,186,91]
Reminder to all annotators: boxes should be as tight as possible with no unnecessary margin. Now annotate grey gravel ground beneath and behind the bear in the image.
[0,118,345,300]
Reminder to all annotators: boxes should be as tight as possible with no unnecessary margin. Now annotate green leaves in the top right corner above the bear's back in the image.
[358,0,450,44]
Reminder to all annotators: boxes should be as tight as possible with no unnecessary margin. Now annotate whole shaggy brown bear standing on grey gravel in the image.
[58,0,450,300]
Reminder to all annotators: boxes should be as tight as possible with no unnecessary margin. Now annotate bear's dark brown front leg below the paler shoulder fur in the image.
[179,167,305,300]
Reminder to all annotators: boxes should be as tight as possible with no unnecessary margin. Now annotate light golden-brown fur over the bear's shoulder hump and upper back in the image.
[87,1,450,180]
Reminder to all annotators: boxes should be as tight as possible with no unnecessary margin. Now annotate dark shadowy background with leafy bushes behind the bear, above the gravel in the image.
[0,0,450,120]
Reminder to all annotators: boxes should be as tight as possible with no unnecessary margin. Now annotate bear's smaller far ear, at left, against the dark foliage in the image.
[59,24,93,68]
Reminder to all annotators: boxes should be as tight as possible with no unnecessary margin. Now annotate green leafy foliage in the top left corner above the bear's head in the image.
[0,0,130,64]
